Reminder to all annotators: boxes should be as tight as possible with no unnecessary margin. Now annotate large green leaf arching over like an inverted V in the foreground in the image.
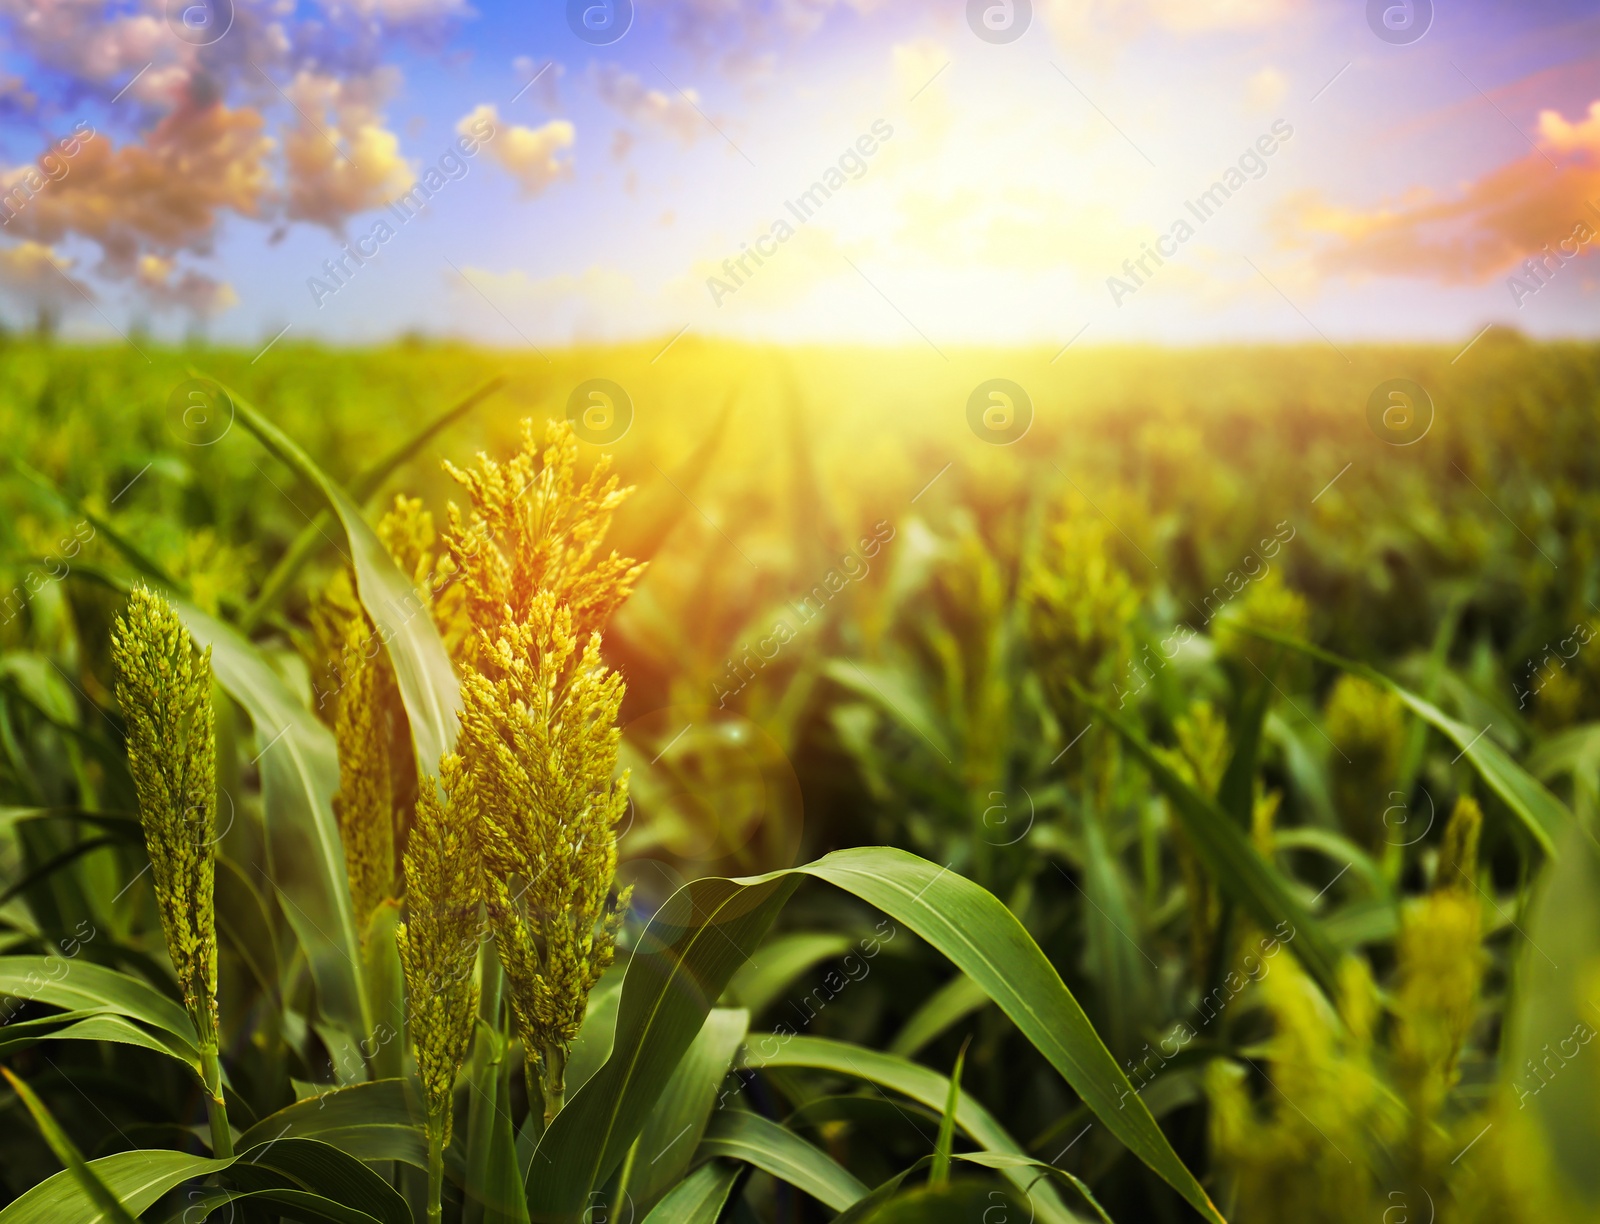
[528,844,1216,1224]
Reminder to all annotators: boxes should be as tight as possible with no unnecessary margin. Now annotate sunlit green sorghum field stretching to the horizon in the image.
[0,333,1600,1224]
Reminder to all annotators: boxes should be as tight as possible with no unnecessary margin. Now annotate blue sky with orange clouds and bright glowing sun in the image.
[0,0,1600,352]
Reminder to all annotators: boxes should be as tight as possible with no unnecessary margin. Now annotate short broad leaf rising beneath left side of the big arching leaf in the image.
[622,1008,750,1211]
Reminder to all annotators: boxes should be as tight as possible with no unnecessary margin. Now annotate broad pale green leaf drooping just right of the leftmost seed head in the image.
[173,602,373,1043]
